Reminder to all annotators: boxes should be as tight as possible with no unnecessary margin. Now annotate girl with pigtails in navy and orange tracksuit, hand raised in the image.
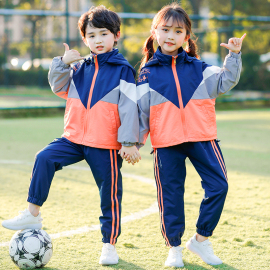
[137,3,245,267]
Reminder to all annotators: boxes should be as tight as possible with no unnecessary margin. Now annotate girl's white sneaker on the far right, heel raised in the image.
[186,234,222,265]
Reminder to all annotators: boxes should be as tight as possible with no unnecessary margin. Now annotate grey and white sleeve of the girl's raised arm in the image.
[201,52,242,98]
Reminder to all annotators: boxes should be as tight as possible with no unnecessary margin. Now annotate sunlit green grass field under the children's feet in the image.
[0,109,270,270]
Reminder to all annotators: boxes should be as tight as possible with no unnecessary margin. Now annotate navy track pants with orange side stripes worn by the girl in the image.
[154,140,228,246]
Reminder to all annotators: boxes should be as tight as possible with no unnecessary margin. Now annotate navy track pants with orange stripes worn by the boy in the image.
[27,138,123,244]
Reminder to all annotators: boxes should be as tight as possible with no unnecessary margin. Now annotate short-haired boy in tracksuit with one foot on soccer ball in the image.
[2,6,140,265]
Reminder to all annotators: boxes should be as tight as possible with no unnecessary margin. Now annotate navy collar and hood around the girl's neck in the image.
[145,47,196,66]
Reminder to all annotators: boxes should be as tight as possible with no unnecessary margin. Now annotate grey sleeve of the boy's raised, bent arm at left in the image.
[48,56,73,99]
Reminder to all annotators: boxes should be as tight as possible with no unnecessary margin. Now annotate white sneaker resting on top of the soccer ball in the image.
[2,209,43,231]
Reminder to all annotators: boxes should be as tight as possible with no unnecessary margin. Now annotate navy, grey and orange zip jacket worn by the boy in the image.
[48,49,139,149]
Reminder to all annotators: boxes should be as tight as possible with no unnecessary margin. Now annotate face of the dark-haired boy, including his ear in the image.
[83,25,120,54]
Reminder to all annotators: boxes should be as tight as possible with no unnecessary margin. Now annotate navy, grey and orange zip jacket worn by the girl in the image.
[137,48,242,148]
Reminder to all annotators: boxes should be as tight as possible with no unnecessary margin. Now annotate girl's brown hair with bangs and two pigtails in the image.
[140,3,199,70]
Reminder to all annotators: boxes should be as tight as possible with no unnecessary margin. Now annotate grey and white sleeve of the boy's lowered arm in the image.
[117,70,139,146]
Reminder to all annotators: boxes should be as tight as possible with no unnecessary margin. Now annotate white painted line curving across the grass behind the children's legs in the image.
[0,160,158,247]
